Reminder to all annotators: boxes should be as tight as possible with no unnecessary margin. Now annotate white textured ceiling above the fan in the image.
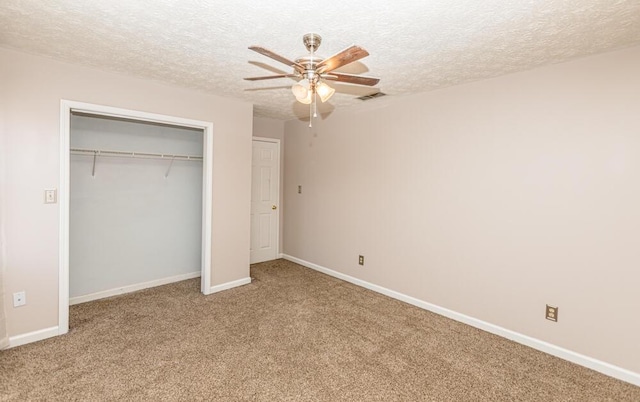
[0,0,640,119]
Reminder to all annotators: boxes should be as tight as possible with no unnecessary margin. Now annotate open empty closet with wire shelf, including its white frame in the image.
[58,101,212,334]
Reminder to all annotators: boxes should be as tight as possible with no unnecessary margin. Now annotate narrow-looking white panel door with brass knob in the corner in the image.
[250,139,280,264]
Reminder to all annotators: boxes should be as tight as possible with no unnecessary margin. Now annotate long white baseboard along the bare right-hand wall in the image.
[283,254,640,386]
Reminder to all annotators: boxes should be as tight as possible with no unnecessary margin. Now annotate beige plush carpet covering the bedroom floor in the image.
[0,260,640,401]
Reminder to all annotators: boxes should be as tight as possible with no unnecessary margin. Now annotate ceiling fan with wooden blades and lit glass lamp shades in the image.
[245,33,380,127]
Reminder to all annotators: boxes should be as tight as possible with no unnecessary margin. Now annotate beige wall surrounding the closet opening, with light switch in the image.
[0,49,252,336]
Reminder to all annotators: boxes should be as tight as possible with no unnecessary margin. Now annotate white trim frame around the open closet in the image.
[58,99,213,335]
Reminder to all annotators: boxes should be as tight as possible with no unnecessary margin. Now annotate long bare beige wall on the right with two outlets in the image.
[284,47,640,373]
